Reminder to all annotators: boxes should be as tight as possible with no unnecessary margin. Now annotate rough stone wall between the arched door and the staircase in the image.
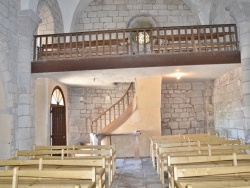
[68,83,130,144]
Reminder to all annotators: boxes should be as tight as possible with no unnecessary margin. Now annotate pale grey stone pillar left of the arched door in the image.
[15,10,41,149]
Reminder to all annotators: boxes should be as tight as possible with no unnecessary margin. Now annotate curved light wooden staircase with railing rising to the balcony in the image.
[90,83,137,136]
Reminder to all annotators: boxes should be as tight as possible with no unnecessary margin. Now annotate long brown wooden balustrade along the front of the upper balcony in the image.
[33,24,239,61]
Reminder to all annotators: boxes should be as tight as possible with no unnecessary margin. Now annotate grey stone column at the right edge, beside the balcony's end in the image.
[226,0,250,143]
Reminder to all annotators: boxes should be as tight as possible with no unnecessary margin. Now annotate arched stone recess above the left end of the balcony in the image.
[37,0,63,34]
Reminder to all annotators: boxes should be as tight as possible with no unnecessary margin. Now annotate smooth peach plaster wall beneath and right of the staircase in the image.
[111,77,161,157]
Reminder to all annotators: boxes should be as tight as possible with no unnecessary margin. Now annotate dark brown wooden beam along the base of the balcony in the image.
[31,51,241,73]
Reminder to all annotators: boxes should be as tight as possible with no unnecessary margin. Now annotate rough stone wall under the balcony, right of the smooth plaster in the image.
[161,81,213,135]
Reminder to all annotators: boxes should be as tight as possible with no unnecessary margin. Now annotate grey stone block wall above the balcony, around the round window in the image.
[73,0,198,31]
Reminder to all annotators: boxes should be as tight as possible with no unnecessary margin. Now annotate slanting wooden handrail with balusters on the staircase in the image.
[90,82,134,133]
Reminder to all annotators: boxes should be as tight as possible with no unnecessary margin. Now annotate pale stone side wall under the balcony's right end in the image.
[214,68,245,140]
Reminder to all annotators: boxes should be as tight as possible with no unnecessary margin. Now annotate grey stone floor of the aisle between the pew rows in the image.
[112,158,166,188]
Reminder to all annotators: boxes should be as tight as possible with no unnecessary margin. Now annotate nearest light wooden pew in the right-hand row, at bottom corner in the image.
[174,166,250,188]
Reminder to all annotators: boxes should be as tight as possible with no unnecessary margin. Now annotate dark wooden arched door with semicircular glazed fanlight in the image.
[50,86,67,146]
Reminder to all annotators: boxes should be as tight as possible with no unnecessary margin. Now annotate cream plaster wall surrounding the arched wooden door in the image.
[35,78,68,145]
